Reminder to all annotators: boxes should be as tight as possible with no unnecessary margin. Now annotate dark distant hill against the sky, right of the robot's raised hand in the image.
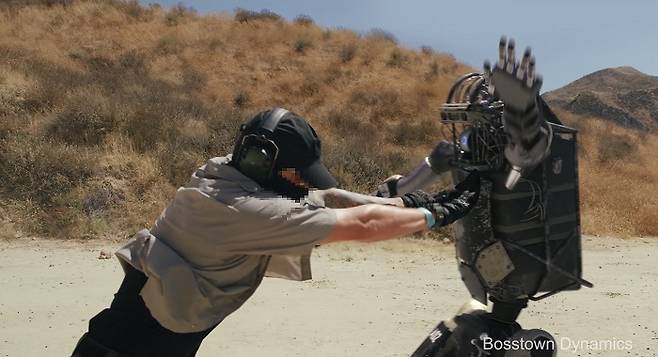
[544,67,658,130]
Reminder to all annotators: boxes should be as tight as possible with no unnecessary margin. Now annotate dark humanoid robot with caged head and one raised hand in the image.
[378,38,592,357]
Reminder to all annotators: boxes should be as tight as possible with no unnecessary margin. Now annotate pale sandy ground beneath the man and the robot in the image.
[0,238,658,357]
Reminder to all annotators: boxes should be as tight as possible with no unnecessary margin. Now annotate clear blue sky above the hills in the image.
[142,0,658,91]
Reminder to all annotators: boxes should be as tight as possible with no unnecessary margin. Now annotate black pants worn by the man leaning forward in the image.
[73,267,216,357]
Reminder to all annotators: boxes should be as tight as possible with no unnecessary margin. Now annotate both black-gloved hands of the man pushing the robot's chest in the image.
[401,171,480,228]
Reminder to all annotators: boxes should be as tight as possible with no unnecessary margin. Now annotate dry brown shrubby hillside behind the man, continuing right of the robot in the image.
[0,0,658,238]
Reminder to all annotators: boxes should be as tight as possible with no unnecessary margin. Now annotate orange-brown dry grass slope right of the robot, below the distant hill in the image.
[558,112,658,236]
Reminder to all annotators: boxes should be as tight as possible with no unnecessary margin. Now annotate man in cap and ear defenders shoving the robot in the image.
[73,108,479,357]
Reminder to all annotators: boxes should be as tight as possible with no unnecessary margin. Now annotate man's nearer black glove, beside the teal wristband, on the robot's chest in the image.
[424,171,480,228]
